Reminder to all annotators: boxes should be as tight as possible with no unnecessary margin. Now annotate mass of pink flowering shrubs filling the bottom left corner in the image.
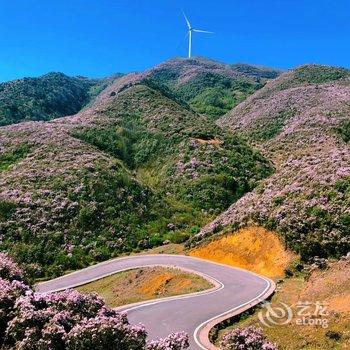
[0,254,188,350]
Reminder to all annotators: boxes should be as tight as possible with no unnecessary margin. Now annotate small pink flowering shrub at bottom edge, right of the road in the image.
[220,326,277,350]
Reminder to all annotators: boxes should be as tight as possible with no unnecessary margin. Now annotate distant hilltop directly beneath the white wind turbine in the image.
[146,57,281,118]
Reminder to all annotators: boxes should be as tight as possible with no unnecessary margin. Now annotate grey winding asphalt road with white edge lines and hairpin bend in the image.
[36,254,275,350]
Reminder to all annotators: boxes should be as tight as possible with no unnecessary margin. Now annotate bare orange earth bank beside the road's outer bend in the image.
[189,227,293,278]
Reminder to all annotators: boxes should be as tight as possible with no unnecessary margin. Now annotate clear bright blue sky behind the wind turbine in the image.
[0,0,350,81]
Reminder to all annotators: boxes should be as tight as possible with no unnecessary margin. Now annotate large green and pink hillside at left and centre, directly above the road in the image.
[0,74,272,276]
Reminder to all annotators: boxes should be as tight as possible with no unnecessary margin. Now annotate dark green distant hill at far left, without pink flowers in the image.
[0,73,113,126]
